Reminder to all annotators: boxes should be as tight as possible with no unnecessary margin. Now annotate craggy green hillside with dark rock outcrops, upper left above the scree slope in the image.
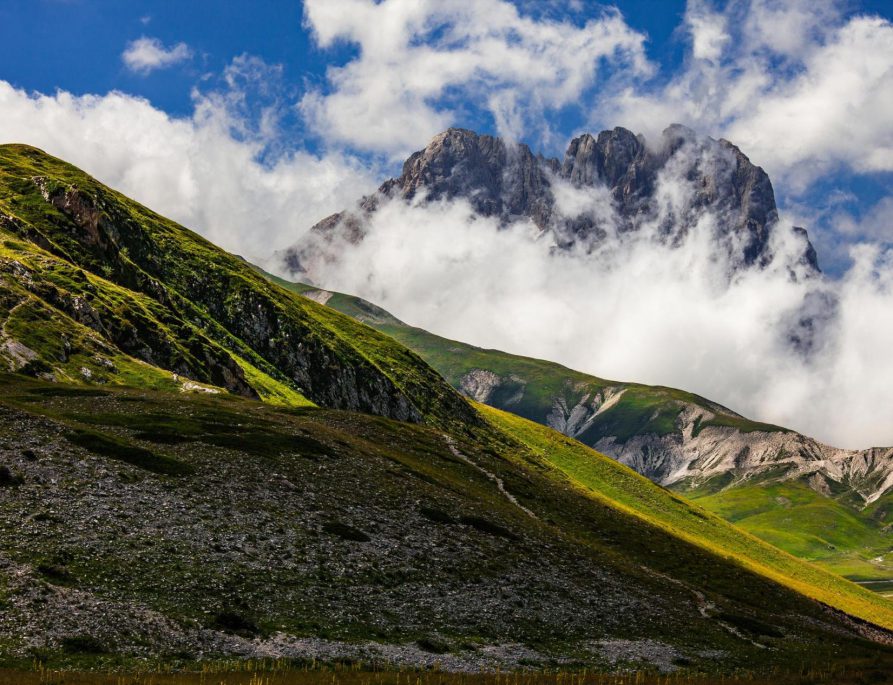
[0,145,475,424]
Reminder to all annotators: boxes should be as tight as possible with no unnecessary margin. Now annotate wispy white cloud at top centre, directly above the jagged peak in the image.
[301,0,652,154]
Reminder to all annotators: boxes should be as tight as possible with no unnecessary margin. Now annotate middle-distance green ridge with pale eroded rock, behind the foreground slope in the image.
[268,275,893,592]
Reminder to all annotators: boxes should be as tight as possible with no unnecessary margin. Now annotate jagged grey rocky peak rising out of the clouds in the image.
[281,124,819,277]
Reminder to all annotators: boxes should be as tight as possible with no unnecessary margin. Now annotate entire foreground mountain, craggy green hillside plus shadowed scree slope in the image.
[0,145,893,673]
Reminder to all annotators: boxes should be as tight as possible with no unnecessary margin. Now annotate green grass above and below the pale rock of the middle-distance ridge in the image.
[267,274,893,592]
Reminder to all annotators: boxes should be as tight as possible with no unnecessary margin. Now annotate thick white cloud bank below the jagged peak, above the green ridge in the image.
[286,182,893,447]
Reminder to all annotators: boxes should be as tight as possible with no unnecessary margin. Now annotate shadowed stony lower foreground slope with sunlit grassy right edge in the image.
[0,375,893,672]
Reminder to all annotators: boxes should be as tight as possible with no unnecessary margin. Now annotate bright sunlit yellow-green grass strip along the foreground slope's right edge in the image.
[477,405,893,629]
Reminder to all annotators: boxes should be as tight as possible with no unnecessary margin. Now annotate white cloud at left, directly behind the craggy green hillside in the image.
[0,74,375,259]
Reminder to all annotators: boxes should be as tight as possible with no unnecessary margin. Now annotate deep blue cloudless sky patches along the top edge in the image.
[0,0,688,123]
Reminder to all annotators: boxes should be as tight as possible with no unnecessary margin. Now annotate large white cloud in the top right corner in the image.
[593,0,893,187]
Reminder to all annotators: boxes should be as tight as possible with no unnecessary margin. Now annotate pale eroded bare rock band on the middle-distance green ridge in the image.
[458,369,893,505]
